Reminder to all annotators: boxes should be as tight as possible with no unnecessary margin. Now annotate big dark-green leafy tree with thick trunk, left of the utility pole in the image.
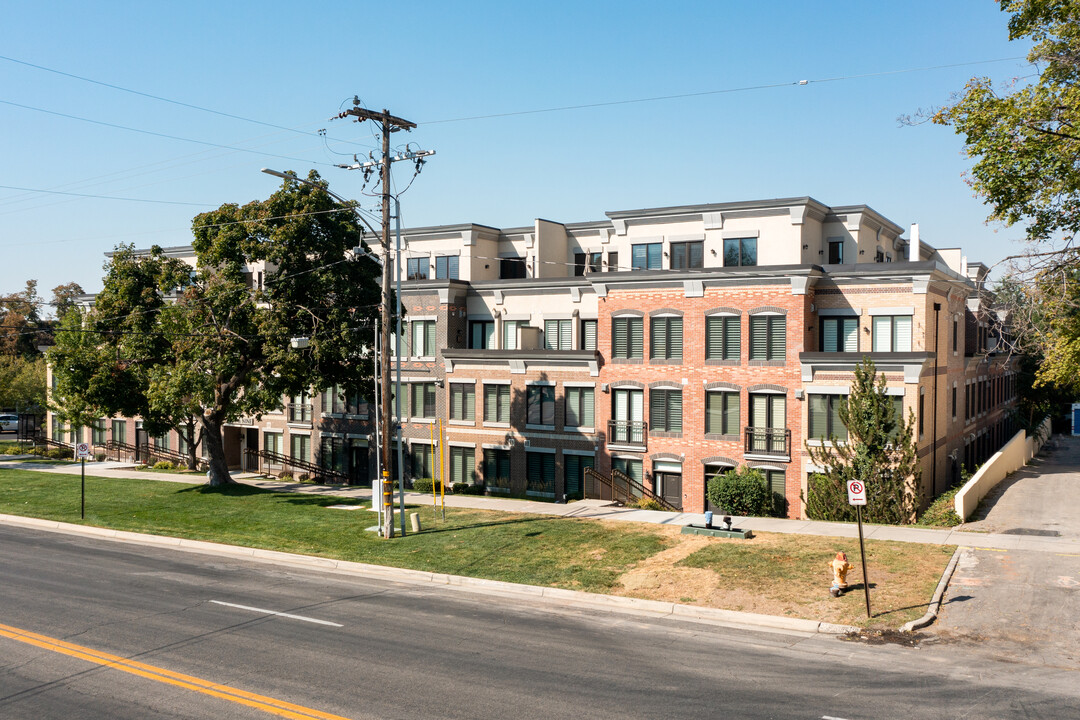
[54,172,380,485]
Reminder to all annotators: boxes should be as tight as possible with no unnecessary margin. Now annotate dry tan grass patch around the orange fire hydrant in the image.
[617,528,954,627]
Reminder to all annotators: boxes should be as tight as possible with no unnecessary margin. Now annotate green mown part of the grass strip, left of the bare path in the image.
[0,470,667,593]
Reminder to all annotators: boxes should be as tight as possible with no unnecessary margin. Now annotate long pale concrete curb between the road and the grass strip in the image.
[0,515,859,635]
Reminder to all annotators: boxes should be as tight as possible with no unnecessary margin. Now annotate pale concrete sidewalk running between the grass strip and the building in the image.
[0,459,1080,554]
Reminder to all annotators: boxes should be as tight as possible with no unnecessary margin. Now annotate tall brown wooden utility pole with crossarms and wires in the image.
[337,98,434,538]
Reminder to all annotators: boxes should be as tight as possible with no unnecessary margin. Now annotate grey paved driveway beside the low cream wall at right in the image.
[935,436,1080,669]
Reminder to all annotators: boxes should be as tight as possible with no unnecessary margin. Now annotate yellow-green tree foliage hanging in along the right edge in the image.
[933,0,1080,390]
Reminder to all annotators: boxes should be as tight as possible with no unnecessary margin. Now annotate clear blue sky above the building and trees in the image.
[0,0,1031,310]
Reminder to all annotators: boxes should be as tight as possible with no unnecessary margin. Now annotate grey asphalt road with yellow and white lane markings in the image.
[0,527,1080,720]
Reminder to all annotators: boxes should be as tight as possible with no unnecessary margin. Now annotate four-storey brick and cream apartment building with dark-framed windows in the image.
[54,198,1015,517]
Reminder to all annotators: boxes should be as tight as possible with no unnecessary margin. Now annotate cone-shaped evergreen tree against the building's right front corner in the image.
[806,358,920,525]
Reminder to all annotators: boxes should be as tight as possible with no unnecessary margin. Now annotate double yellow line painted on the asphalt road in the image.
[0,625,348,720]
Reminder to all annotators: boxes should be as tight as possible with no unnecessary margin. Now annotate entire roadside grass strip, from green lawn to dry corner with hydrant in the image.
[0,468,951,627]
